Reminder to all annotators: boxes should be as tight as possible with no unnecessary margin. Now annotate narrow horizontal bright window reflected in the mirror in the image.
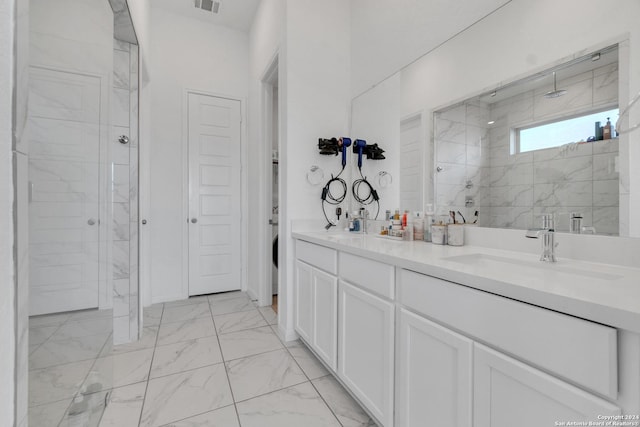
[515,108,618,153]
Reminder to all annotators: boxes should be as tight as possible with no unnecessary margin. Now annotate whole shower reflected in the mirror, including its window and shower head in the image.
[434,46,619,235]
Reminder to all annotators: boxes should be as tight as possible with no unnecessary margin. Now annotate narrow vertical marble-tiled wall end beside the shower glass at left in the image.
[111,40,139,344]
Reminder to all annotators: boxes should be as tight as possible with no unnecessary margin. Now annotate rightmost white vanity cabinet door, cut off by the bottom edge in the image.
[473,343,621,427]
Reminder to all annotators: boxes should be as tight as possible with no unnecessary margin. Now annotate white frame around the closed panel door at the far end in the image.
[181,88,248,299]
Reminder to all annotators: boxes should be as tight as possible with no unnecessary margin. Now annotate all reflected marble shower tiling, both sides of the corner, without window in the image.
[435,64,620,234]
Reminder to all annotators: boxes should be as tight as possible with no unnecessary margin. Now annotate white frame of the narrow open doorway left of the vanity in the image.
[254,51,282,307]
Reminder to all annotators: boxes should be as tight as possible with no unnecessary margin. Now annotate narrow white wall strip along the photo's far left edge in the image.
[0,1,16,426]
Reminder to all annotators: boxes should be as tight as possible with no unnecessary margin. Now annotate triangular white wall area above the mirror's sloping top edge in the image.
[350,0,507,96]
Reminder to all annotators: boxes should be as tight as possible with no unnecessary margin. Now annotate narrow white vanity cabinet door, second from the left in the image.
[312,268,338,371]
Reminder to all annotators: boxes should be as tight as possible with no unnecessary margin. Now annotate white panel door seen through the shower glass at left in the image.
[28,67,100,315]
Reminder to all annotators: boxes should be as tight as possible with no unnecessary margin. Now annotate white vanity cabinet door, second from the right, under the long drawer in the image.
[396,309,473,427]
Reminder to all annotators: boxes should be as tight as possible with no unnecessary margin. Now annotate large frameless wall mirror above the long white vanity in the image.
[351,0,640,241]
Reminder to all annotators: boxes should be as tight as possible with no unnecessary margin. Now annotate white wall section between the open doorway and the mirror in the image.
[278,0,351,337]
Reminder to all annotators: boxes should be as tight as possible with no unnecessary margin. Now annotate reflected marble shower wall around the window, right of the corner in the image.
[489,64,619,234]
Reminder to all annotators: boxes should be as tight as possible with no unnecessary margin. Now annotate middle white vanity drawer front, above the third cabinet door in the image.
[340,252,395,299]
